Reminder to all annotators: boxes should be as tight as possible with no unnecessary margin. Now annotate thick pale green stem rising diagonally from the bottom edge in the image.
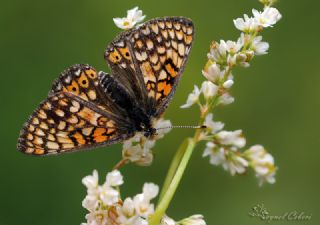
[149,138,195,225]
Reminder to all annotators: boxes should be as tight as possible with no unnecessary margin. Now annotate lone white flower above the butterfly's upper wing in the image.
[113,7,146,30]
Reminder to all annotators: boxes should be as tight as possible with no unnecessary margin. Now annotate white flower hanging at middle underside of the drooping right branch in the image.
[222,152,249,176]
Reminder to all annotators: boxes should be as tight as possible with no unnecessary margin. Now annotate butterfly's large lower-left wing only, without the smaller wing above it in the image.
[18,92,131,155]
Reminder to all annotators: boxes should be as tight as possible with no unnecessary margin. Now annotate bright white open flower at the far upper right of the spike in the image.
[252,7,282,27]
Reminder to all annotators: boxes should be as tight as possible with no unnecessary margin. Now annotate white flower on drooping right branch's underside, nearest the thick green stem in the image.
[202,142,226,166]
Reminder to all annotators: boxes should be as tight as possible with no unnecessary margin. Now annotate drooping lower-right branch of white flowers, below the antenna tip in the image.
[201,114,276,185]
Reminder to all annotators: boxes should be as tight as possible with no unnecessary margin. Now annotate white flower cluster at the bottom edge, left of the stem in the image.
[82,170,159,225]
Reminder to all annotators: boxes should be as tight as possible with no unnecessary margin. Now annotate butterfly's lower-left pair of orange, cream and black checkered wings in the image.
[18,65,133,155]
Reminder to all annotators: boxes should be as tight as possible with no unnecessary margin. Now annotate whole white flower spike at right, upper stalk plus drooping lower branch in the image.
[181,0,281,184]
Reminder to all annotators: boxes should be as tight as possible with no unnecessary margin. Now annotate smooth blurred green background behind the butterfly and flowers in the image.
[0,0,320,225]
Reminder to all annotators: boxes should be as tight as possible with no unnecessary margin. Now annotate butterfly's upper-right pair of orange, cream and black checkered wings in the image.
[105,17,194,117]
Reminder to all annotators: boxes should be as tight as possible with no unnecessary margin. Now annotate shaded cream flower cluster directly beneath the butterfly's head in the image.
[122,118,172,166]
